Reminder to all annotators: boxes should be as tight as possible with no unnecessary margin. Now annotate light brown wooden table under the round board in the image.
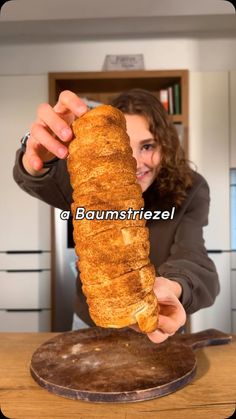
[0,333,236,419]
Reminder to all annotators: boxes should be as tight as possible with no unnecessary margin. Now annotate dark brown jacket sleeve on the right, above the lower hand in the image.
[158,180,220,314]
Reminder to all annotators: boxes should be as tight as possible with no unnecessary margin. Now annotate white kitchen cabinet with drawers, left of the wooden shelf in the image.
[0,75,51,331]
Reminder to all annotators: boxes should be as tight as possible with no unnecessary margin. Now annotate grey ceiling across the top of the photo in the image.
[0,0,236,44]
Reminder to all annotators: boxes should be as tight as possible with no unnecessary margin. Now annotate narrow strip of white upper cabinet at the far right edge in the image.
[230,71,236,168]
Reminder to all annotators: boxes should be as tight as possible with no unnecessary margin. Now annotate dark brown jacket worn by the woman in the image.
[13,150,219,324]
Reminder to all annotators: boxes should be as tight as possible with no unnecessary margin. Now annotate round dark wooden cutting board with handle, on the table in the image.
[30,327,231,402]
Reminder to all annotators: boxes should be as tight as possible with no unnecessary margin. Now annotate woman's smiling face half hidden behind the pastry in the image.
[125,114,161,192]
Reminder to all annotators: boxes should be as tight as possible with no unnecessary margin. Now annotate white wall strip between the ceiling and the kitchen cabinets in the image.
[0,36,236,75]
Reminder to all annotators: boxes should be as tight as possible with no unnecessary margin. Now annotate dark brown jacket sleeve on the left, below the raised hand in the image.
[13,150,72,211]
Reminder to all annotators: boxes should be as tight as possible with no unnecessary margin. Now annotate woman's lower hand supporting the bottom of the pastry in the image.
[132,276,186,343]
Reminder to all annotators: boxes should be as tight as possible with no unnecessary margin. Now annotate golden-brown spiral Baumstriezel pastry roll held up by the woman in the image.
[68,105,158,332]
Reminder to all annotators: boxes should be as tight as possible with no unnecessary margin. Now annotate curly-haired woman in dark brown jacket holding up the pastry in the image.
[14,89,219,343]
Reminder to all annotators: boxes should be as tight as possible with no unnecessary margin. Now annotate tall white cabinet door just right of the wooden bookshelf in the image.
[189,72,230,250]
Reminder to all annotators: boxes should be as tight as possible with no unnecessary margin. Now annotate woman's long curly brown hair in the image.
[111,89,193,207]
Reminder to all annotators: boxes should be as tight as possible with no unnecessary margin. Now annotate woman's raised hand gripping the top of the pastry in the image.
[22,90,87,176]
